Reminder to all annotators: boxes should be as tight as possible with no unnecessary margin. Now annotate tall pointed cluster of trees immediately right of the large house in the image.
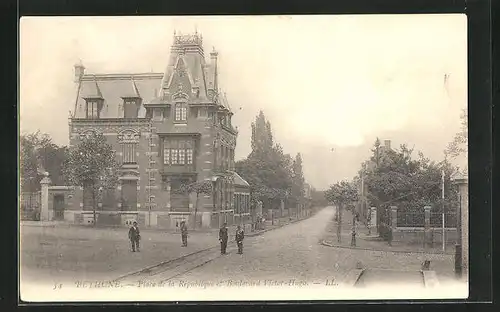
[235,111,305,218]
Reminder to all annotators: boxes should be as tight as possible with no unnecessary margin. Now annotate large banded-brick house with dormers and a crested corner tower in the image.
[65,33,249,228]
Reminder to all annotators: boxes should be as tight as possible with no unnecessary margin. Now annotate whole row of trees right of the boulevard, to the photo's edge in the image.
[325,110,467,243]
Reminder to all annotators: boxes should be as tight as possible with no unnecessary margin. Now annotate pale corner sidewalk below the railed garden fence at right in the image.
[324,211,454,255]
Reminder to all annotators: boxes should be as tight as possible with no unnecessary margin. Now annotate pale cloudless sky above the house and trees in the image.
[19,14,467,189]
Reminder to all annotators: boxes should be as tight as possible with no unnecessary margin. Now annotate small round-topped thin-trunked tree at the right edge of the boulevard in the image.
[325,181,359,243]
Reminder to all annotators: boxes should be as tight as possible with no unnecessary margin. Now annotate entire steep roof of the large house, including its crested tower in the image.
[73,33,230,118]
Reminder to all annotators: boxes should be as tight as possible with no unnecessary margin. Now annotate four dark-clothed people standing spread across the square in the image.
[128,221,245,255]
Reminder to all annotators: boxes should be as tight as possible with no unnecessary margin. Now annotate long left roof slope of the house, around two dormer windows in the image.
[73,73,163,118]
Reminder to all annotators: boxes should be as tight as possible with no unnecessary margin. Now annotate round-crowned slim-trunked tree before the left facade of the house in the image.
[64,133,119,225]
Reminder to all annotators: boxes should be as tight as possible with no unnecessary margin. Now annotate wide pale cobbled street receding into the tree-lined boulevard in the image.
[143,207,453,285]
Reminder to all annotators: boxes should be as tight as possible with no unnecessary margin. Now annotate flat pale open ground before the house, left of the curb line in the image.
[20,226,219,281]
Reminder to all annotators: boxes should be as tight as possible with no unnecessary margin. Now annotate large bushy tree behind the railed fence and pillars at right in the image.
[364,138,457,237]
